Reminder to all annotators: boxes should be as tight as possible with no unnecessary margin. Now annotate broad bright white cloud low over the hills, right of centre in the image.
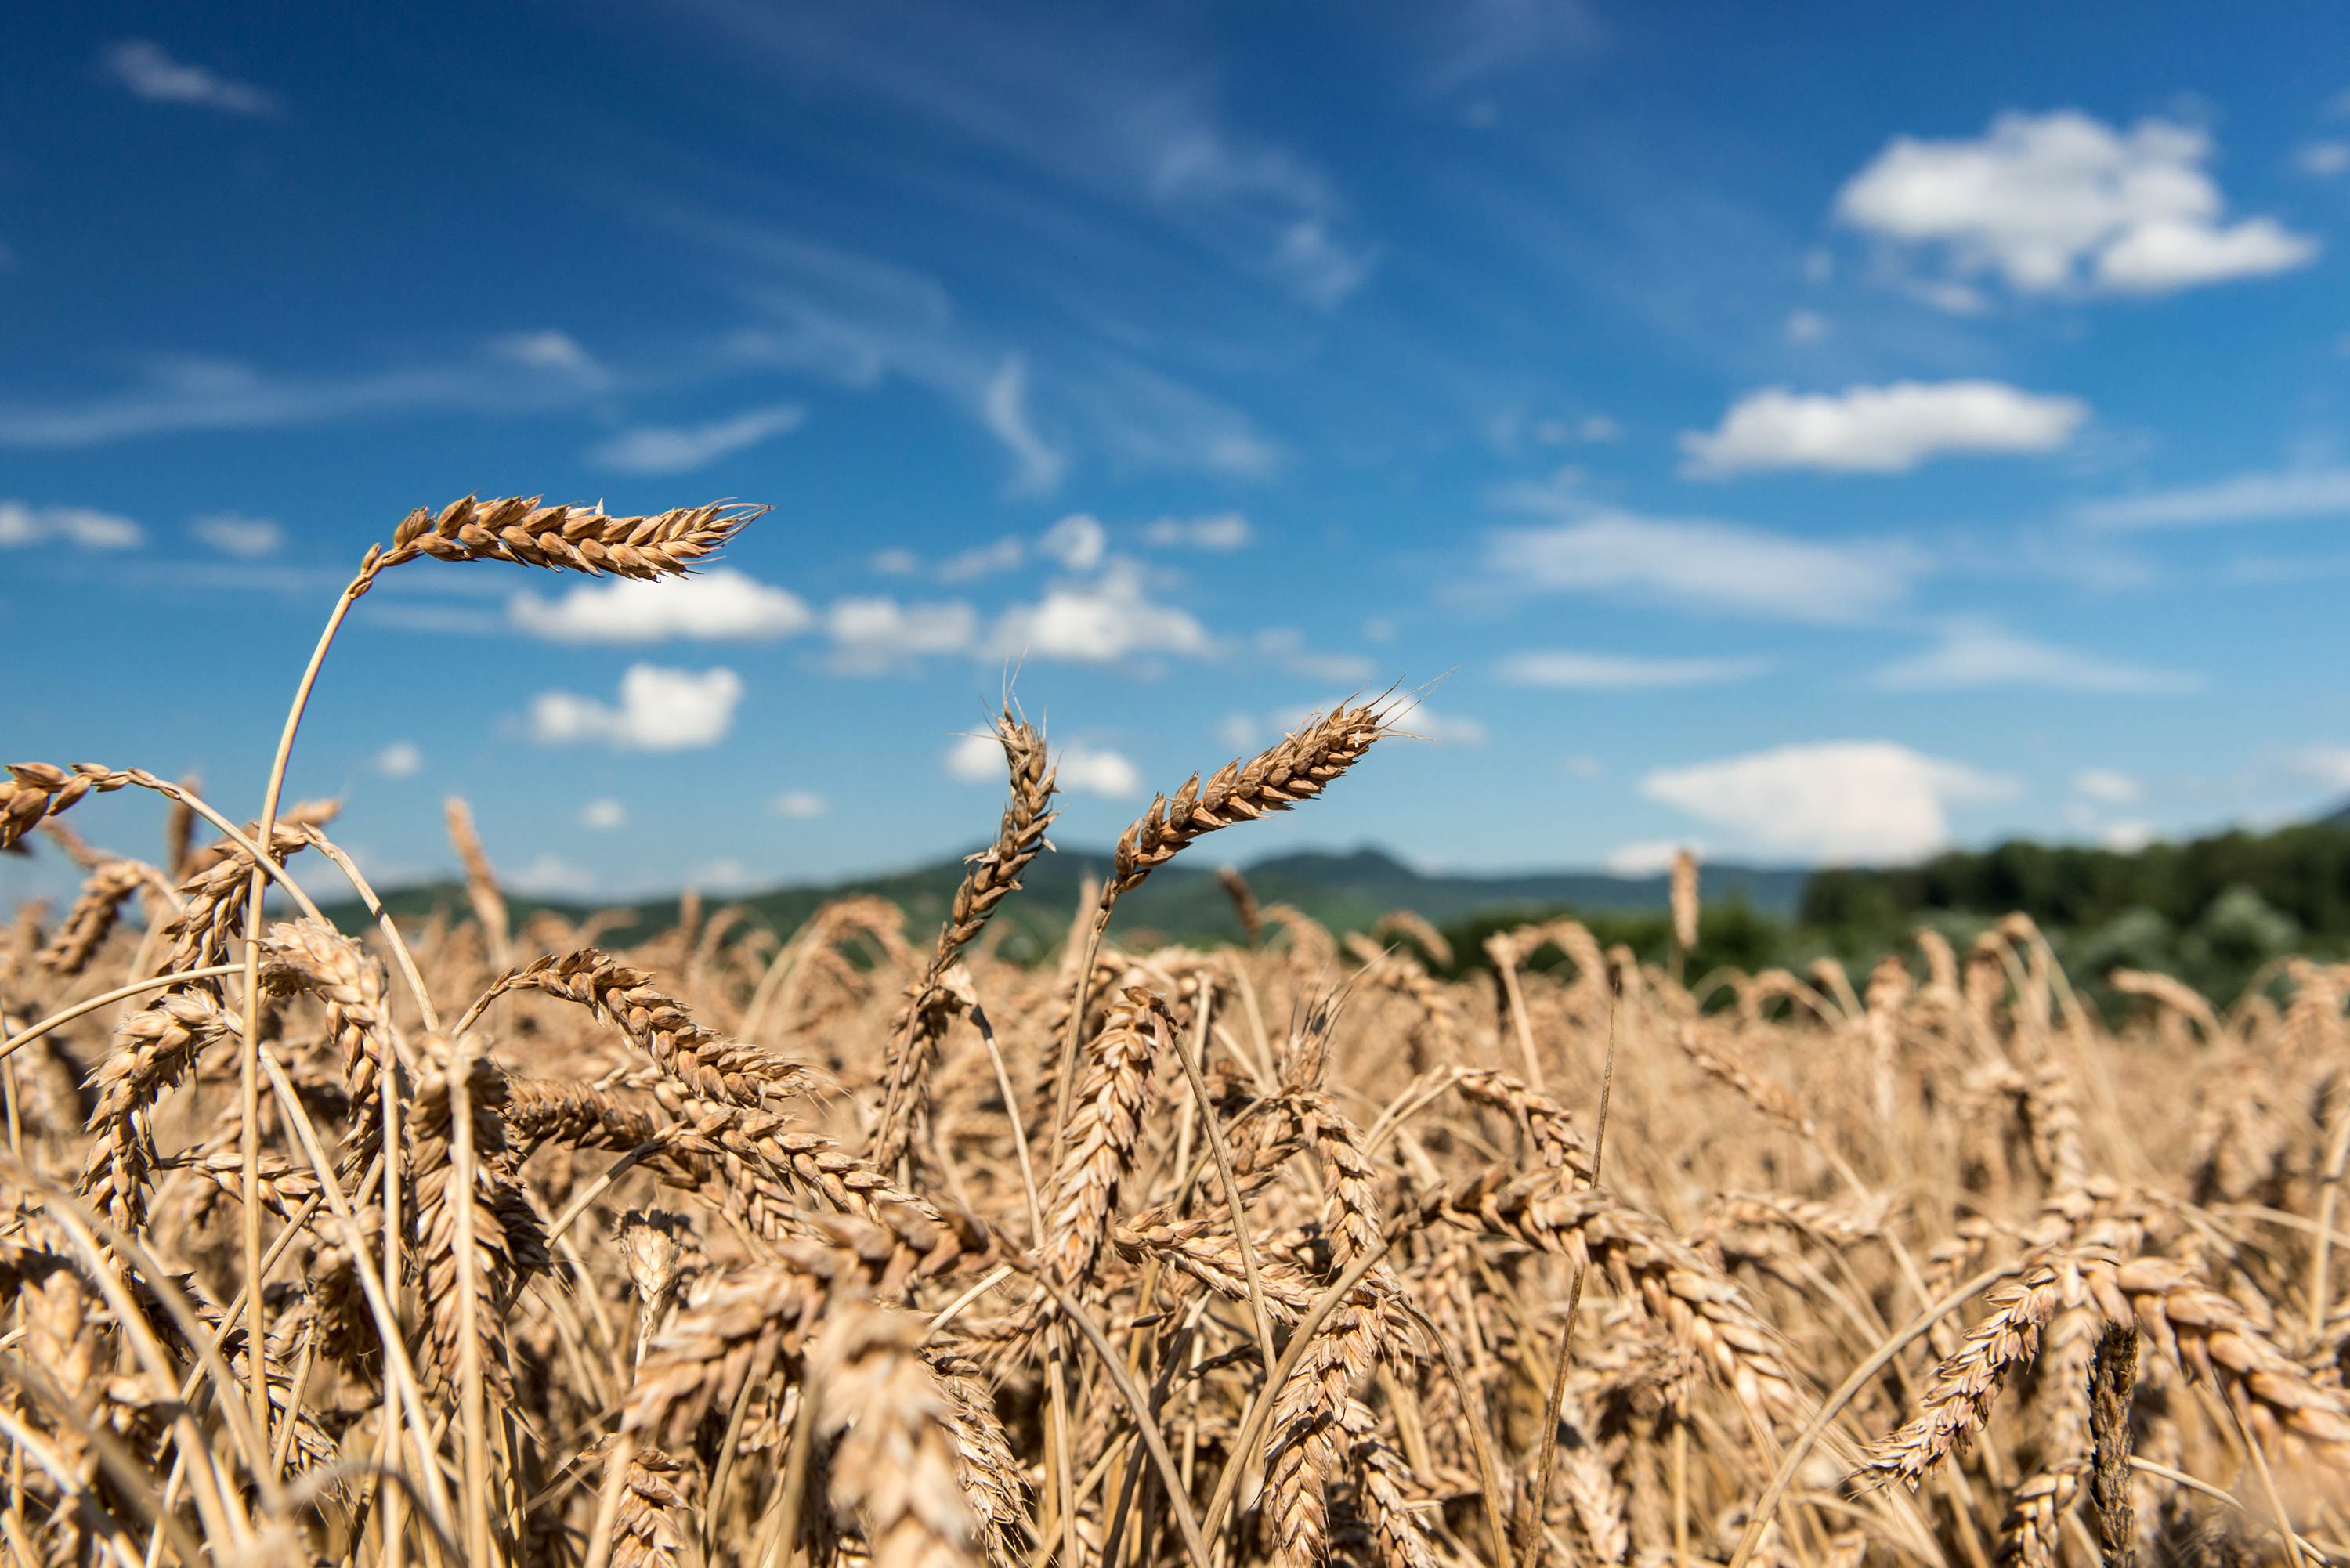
[1640,740,2016,863]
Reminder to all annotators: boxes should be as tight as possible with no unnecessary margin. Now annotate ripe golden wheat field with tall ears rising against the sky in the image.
[0,498,2350,1568]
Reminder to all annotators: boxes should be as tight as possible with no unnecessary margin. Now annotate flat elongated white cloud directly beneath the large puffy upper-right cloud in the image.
[1680,381,2089,475]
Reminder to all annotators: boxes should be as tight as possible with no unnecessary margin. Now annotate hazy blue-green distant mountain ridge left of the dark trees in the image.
[324,849,1810,955]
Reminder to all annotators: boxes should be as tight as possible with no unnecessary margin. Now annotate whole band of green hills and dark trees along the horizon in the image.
[331,821,2350,1016]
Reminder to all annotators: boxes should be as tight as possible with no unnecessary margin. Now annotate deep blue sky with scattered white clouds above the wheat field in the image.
[0,0,2350,896]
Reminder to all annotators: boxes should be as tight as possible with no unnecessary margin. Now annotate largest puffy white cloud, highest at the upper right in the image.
[1835,108,2317,294]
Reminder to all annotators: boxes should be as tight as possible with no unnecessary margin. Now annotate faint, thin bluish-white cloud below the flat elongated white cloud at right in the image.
[1485,510,1925,620]
